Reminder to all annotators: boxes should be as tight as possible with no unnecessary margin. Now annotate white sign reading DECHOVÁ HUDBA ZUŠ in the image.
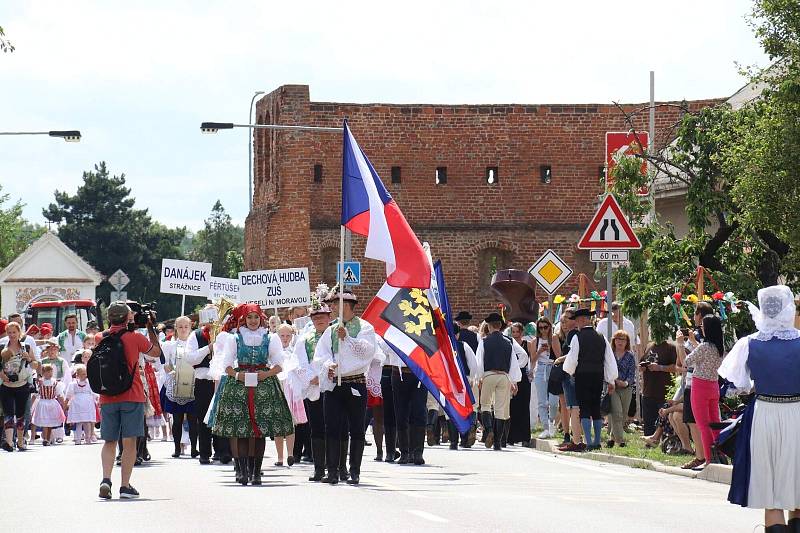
[239,268,311,309]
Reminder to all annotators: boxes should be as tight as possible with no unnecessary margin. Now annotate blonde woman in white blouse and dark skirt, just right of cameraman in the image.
[159,316,199,458]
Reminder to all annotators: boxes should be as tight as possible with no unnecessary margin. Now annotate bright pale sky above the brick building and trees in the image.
[0,0,767,230]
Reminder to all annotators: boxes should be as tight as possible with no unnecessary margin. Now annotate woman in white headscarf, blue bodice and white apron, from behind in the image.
[719,285,800,533]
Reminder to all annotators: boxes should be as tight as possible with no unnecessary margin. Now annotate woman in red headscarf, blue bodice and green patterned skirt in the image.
[211,304,294,485]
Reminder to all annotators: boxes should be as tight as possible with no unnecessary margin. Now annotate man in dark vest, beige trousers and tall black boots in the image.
[475,313,528,450]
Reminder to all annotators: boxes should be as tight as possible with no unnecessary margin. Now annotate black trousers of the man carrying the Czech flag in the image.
[324,383,367,442]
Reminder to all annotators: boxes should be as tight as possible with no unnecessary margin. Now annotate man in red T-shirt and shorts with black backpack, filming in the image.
[100,302,161,500]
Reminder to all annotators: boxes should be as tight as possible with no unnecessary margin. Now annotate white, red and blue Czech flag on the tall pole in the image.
[342,121,431,289]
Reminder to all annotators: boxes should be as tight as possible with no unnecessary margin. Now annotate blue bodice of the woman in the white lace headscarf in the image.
[747,337,800,396]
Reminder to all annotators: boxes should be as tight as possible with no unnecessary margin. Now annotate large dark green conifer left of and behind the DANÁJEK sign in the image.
[42,161,186,317]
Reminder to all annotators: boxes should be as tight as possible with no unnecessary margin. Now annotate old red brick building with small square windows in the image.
[245,85,718,317]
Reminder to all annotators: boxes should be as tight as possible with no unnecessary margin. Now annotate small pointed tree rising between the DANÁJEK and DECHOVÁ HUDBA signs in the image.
[191,200,244,277]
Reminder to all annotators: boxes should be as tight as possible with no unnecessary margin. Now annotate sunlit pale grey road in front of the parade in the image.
[0,434,761,533]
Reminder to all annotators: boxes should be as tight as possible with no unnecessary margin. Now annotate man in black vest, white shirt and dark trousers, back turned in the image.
[564,309,618,450]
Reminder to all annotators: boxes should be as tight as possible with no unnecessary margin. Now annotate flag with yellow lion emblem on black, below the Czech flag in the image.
[361,262,474,433]
